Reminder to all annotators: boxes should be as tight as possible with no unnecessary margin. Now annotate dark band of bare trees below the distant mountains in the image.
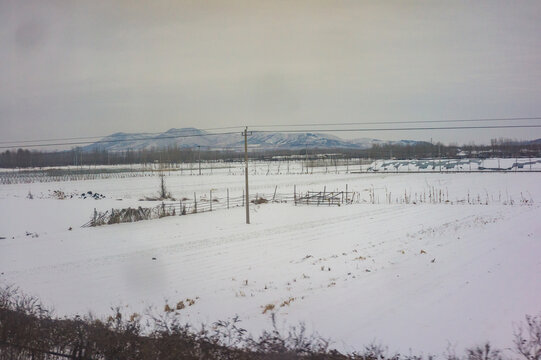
[0,139,541,168]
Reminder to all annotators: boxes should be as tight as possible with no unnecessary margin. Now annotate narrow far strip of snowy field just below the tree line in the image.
[4,158,541,185]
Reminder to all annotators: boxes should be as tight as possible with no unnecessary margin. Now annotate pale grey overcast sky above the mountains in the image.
[0,0,541,143]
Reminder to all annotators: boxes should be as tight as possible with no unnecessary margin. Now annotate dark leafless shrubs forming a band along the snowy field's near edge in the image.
[0,287,541,360]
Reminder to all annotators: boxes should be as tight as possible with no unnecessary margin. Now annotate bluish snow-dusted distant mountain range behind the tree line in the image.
[83,128,426,151]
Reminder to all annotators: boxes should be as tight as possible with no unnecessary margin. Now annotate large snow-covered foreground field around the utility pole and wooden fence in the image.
[0,164,541,354]
